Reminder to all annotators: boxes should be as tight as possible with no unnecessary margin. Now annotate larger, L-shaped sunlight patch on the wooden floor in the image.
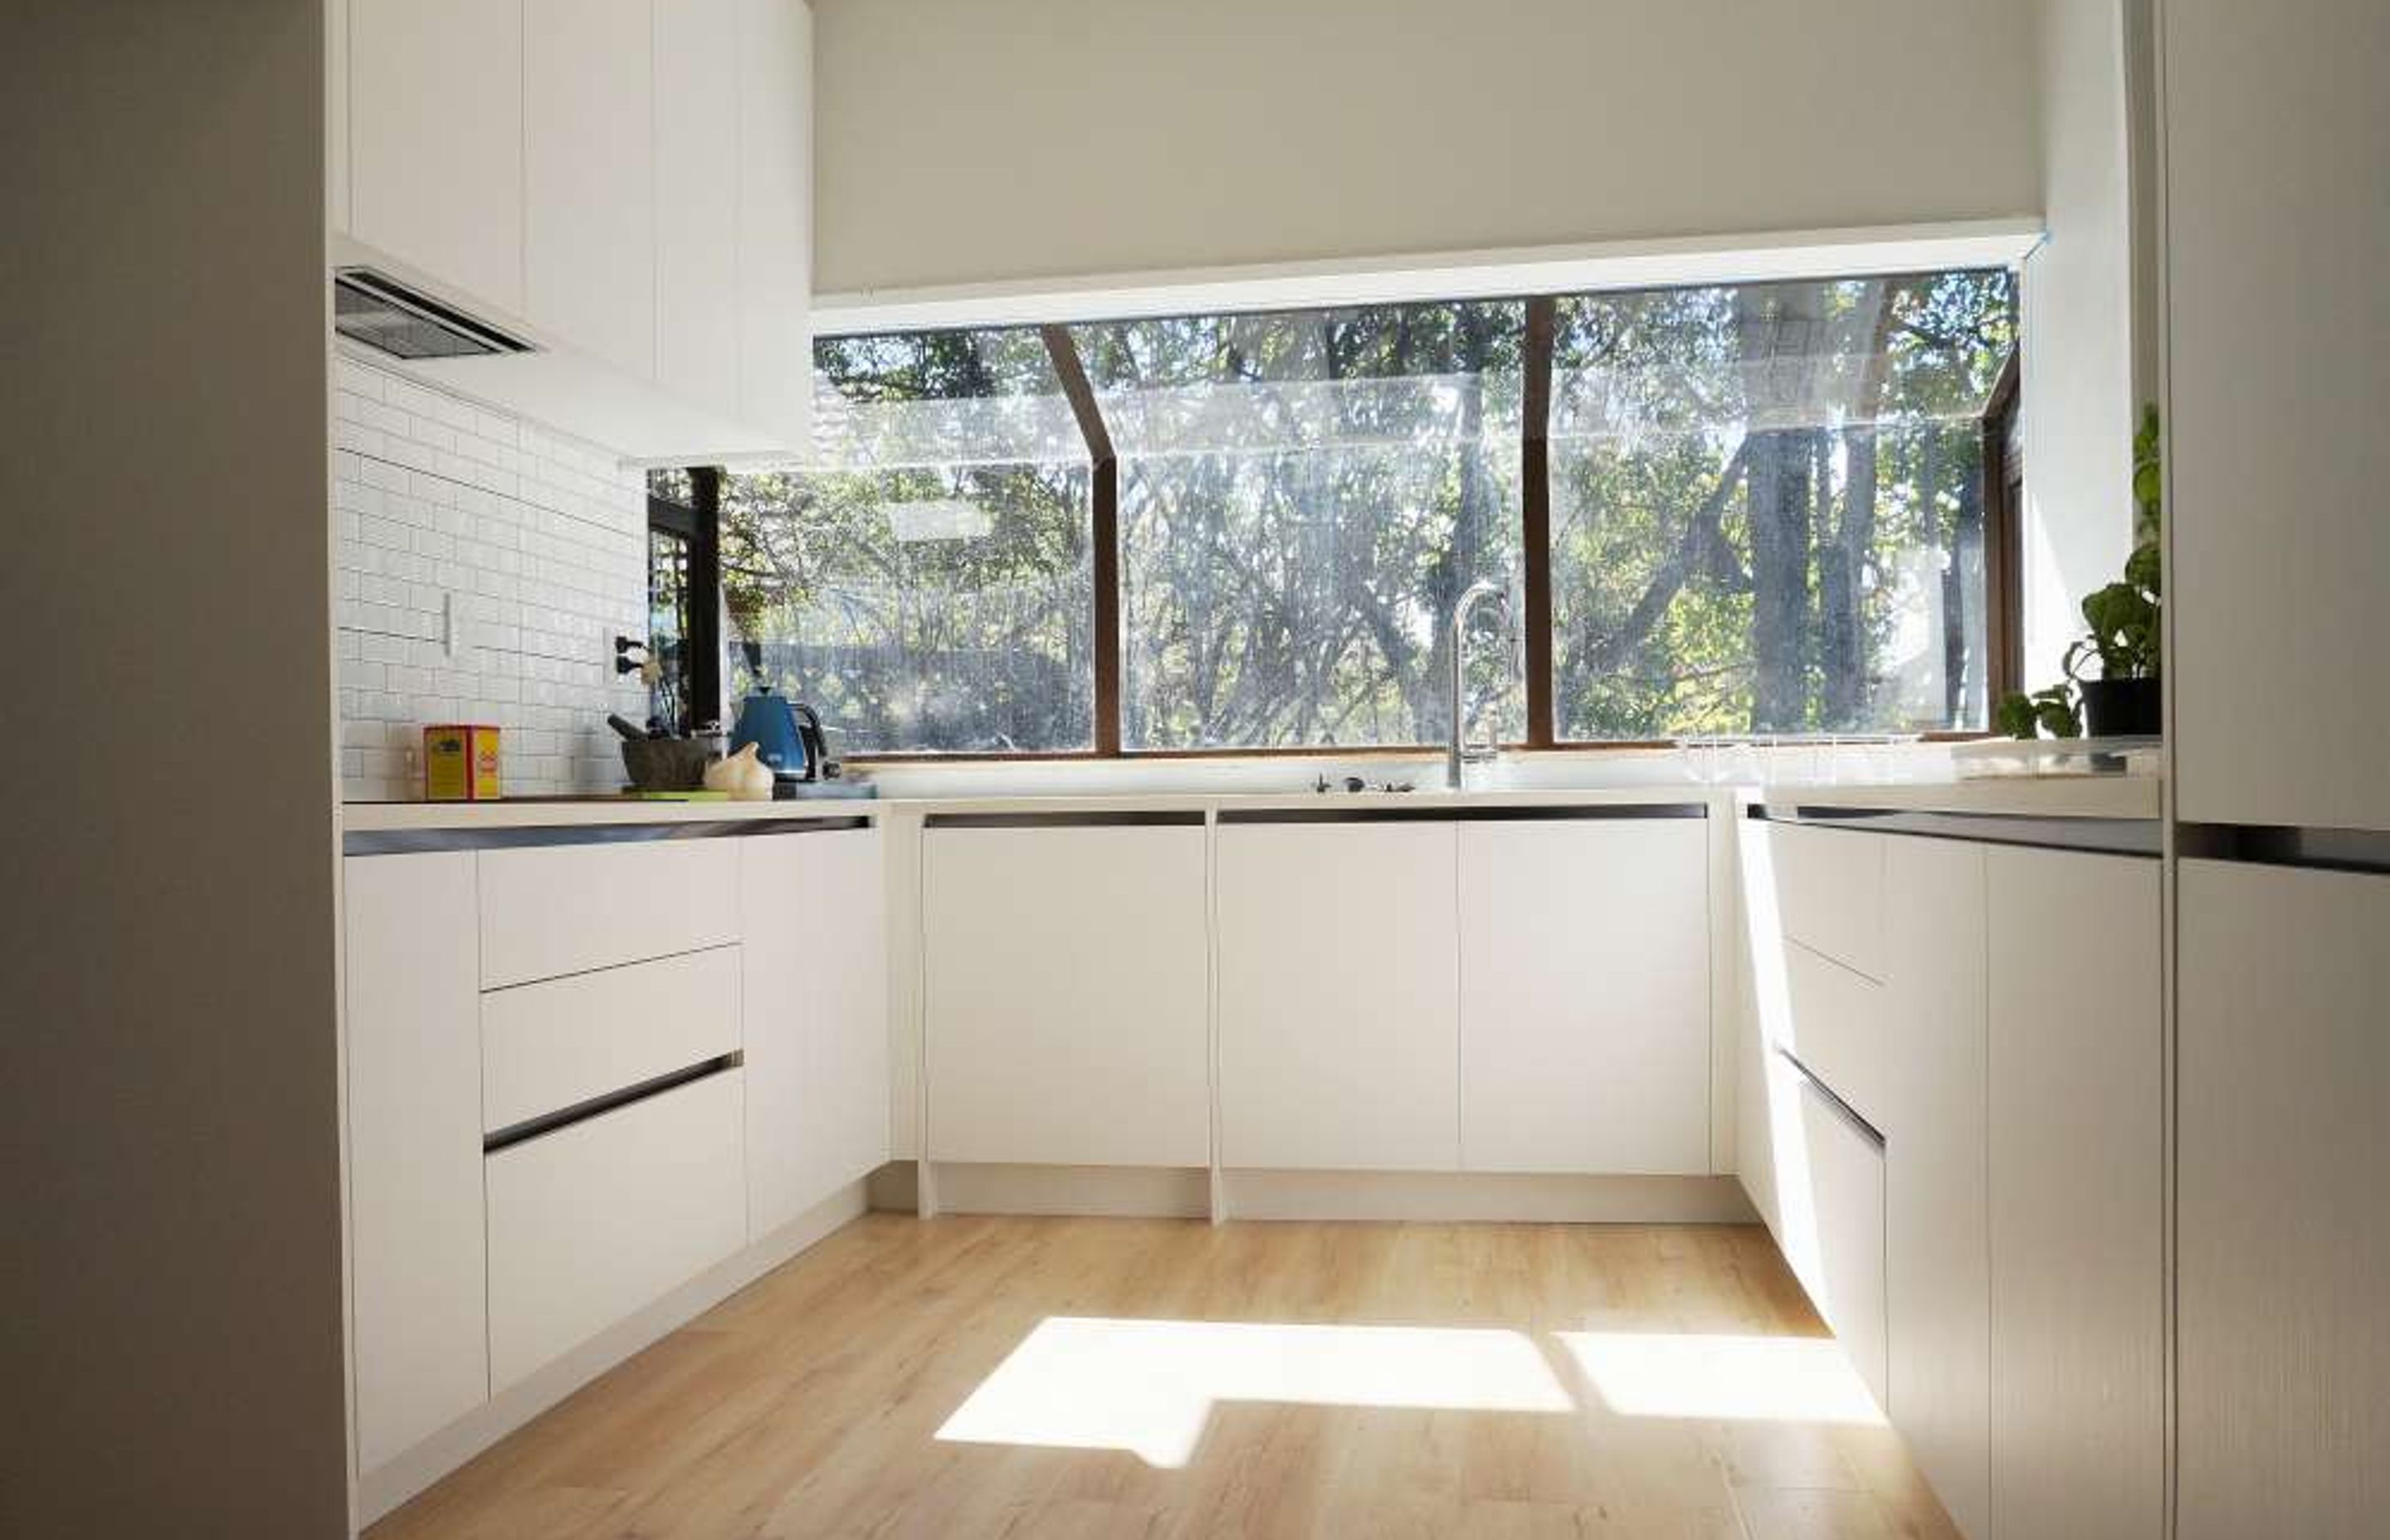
[937,1315,1578,1470]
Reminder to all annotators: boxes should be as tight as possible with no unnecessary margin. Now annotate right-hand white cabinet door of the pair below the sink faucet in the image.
[1458,818,1711,1174]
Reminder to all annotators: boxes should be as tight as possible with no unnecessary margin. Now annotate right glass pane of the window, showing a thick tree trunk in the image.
[1549,273,2015,741]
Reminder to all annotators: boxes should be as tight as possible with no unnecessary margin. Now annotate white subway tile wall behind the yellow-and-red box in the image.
[332,354,647,801]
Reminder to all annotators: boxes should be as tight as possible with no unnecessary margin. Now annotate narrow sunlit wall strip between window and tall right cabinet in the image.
[2024,0,2153,689]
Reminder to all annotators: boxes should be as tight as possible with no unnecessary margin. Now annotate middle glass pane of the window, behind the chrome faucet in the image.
[1071,304,1524,751]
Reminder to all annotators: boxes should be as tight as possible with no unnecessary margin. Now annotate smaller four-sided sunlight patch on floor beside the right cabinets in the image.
[1556,1332,1883,1428]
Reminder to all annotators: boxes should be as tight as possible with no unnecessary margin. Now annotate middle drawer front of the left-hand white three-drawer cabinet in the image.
[480,947,741,1133]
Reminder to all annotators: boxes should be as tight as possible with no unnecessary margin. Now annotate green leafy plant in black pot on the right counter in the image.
[1998,407,2163,739]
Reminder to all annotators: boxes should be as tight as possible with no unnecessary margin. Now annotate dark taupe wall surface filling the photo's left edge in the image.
[0,0,349,1540]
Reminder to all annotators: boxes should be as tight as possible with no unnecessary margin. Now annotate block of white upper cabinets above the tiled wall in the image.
[328,0,812,459]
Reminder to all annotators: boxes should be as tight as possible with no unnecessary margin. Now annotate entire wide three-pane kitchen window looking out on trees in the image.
[697,270,2017,756]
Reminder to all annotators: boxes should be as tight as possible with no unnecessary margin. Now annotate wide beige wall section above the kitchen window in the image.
[815,0,2041,294]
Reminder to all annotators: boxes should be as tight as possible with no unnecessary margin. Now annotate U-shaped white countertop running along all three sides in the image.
[342,775,2161,832]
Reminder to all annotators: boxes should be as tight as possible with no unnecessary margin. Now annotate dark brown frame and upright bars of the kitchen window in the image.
[683,282,2024,765]
